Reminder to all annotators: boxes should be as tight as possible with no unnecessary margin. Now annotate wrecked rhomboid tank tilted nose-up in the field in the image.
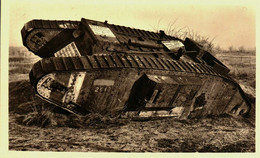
[21,18,250,119]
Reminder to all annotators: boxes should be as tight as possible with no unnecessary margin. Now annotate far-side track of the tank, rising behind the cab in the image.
[21,19,182,55]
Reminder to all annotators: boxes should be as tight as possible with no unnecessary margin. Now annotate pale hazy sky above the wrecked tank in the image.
[9,0,256,49]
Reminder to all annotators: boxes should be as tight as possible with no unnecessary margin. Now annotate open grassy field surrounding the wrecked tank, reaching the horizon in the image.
[9,48,255,152]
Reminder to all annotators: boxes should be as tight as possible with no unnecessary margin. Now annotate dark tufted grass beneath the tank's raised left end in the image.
[16,105,128,129]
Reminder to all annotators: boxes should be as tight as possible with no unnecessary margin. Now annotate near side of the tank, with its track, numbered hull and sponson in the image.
[30,54,250,119]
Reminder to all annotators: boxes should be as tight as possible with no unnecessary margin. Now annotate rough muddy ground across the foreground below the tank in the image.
[9,111,255,152]
